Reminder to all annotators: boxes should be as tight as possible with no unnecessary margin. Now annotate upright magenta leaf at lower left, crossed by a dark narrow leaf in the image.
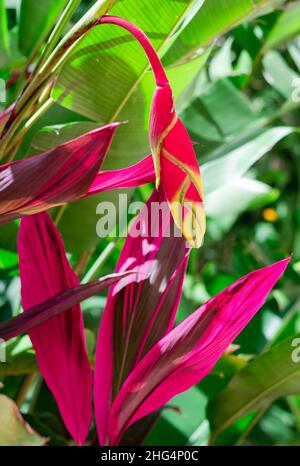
[18,212,92,445]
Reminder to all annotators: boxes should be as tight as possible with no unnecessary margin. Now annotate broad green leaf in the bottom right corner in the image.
[209,334,300,439]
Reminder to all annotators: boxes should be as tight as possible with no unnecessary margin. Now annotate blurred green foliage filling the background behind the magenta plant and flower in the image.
[0,0,300,445]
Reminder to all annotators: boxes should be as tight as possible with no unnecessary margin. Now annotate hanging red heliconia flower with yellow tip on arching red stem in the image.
[98,16,205,247]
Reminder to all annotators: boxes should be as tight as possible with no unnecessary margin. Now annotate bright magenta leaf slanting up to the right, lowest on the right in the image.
[102,258,290,445]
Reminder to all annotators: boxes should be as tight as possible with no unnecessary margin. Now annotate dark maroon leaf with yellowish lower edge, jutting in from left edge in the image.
[0,123,118,224]
